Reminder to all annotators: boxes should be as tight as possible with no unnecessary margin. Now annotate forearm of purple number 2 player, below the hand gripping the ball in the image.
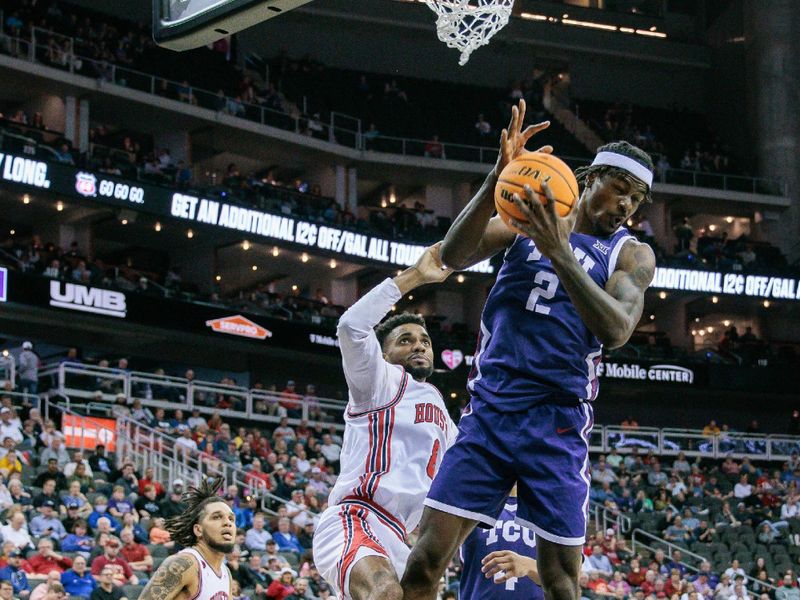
[551,247,636,348]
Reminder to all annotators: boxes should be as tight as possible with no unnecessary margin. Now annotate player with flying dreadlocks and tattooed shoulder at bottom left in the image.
[139,478,231,600]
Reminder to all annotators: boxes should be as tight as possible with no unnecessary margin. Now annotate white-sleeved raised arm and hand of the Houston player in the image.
[336,243,452,404]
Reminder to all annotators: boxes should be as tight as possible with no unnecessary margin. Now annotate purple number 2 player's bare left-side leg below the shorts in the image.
[402,506,478,600]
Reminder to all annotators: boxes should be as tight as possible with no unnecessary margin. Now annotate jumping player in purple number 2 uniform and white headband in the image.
[401,101,655,600]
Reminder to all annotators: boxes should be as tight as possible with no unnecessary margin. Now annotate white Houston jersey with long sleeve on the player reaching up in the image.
[328,279,457,538]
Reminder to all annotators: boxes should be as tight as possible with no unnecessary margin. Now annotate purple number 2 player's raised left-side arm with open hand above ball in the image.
[442,100,553,269]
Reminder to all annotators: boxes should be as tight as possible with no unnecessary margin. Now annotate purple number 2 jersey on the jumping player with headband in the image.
[467,227,632,411]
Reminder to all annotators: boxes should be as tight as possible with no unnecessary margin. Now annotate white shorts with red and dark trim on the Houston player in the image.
[314,500,411,600]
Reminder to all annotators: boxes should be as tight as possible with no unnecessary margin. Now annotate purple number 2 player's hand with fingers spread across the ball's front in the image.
[511,181,578,260]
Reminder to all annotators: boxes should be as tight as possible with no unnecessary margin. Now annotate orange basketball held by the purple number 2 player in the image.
[494,152,578,235]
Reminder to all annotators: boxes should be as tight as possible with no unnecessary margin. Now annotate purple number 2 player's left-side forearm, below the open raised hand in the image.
[441,169,497,269]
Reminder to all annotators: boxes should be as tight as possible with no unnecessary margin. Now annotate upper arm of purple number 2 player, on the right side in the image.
[605,240,656,347]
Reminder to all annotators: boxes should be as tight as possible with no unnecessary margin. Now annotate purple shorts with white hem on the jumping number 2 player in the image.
[425,398,594,546]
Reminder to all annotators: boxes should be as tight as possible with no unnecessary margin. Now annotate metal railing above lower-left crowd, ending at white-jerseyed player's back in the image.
[39,361,347,431]
